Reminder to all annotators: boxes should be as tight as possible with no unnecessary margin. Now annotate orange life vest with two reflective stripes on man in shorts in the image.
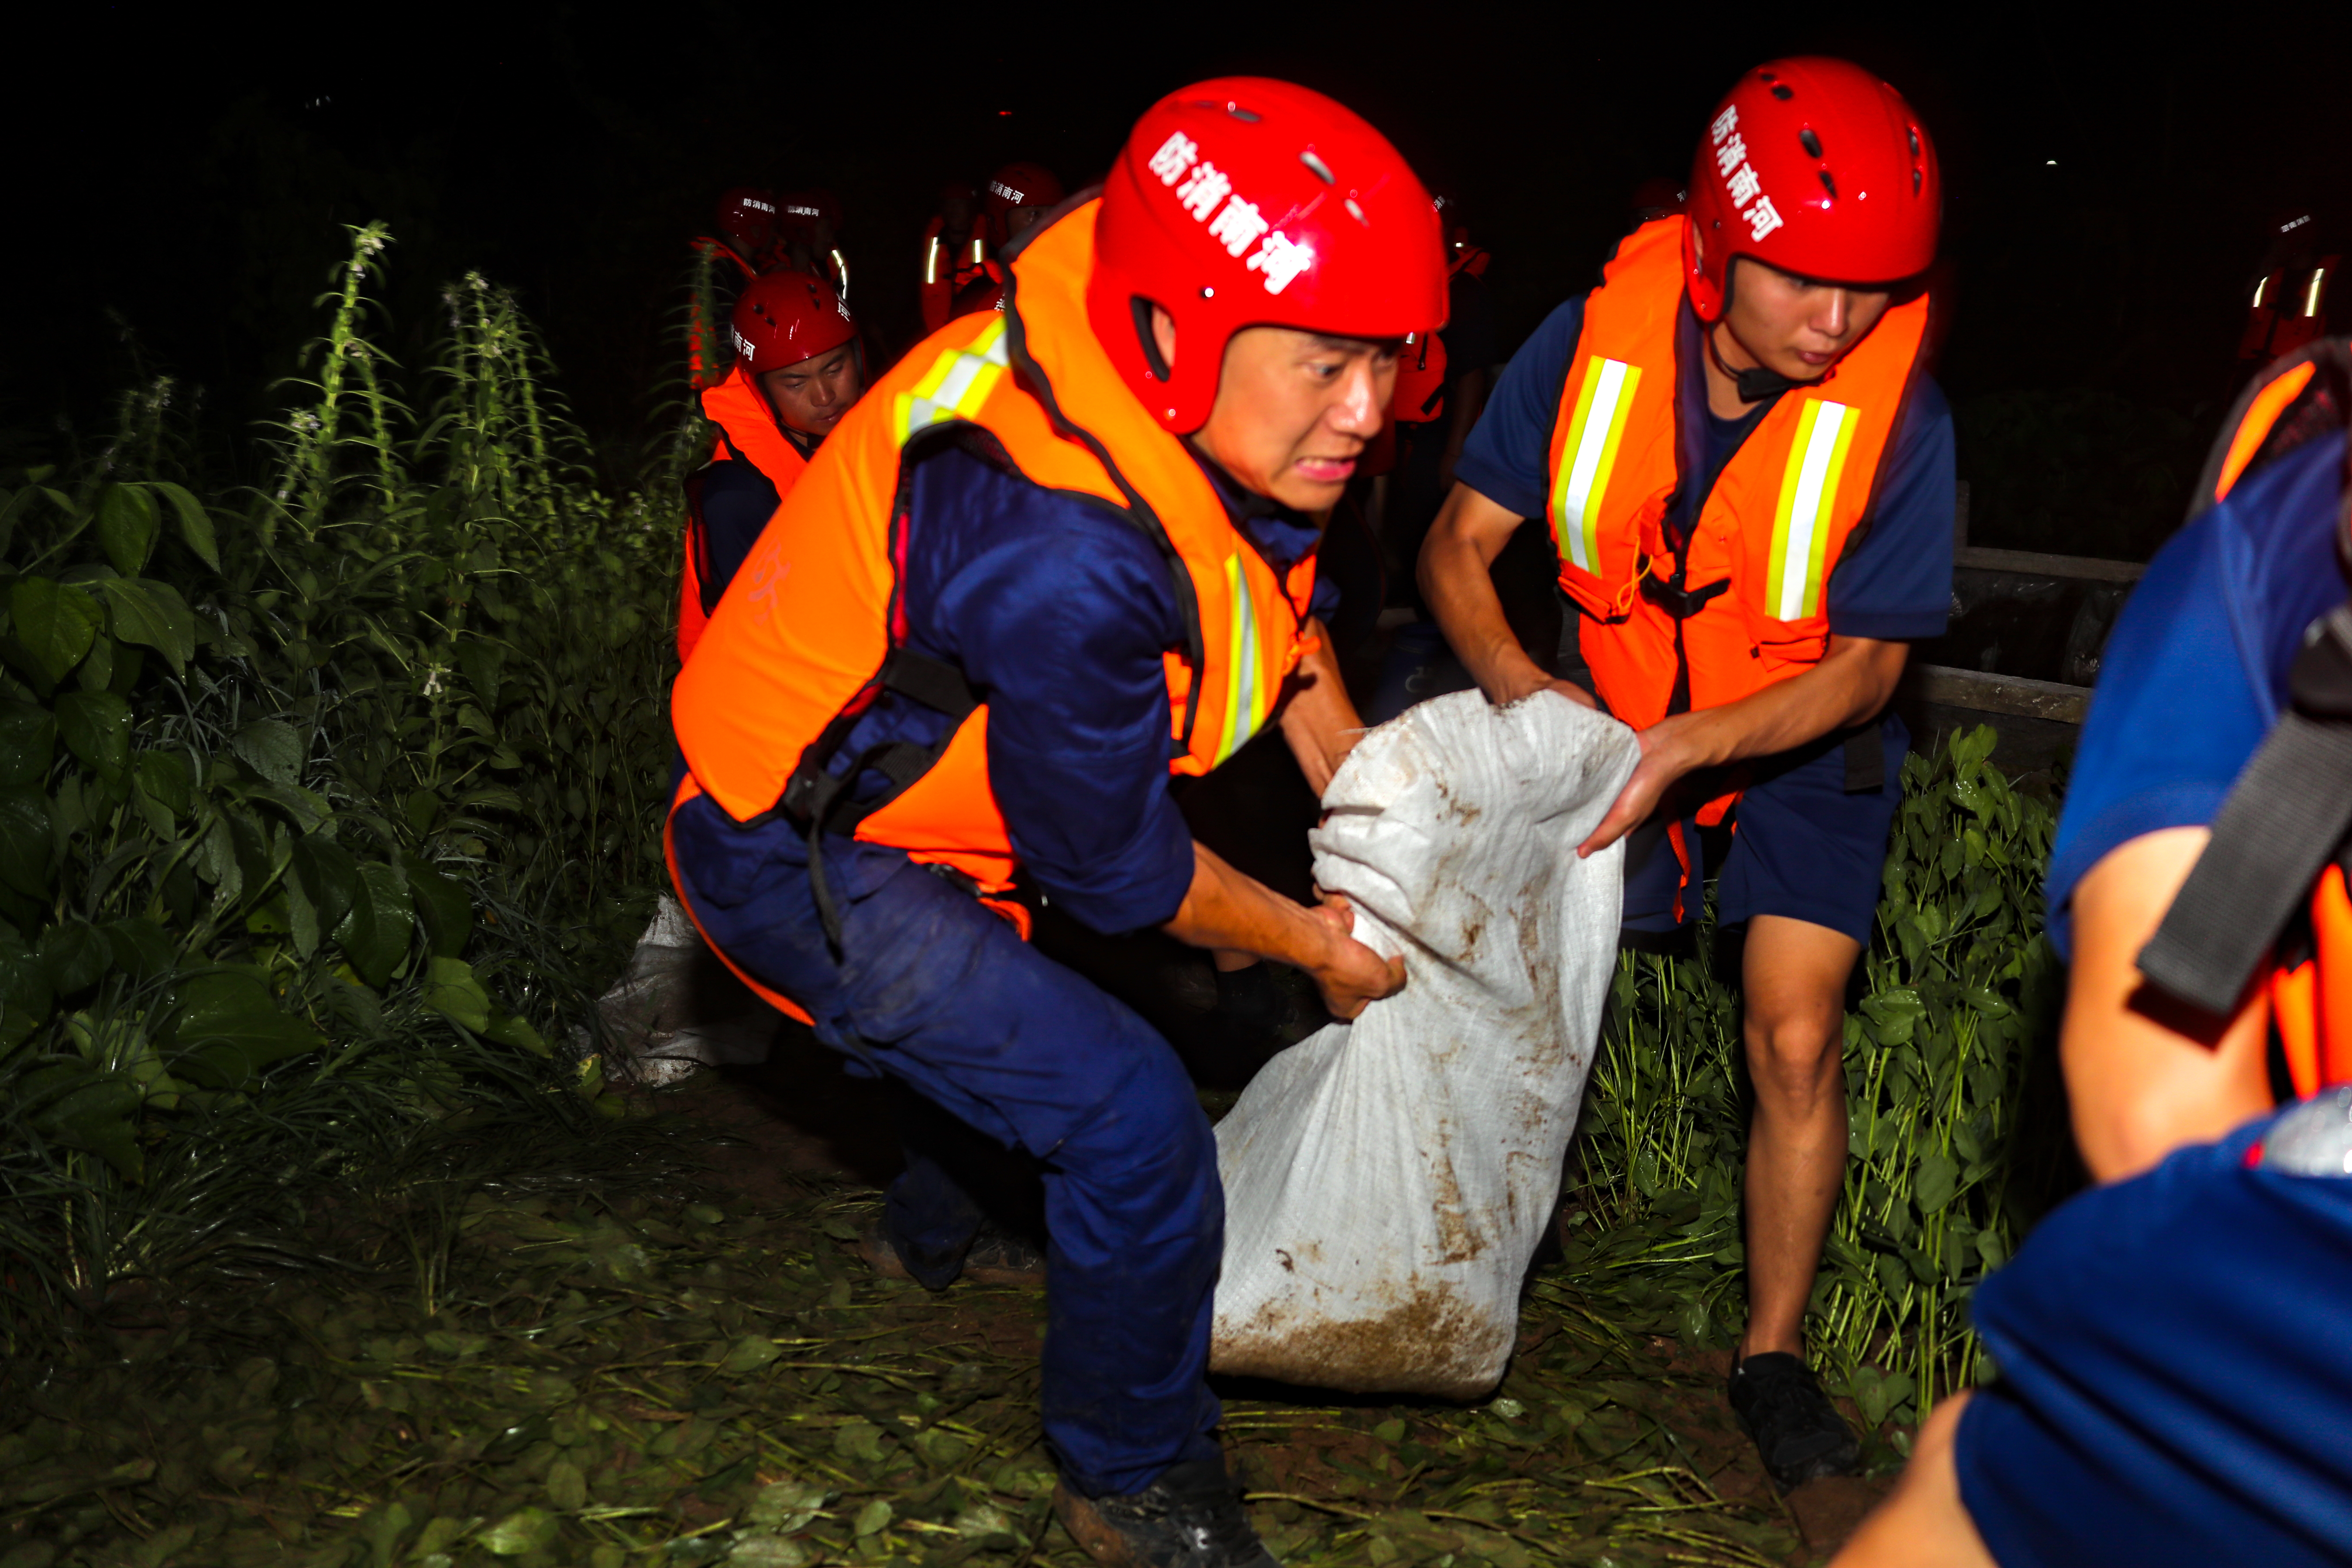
[1545,214,1929,821]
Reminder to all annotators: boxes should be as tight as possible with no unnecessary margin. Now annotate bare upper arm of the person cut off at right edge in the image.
[2058,827,2269,1182]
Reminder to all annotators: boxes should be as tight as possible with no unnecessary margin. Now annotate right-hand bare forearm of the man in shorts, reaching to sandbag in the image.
[1576,635,1910,856]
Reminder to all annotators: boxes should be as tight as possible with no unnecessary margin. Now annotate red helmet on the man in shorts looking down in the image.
[1681,56,1943,322]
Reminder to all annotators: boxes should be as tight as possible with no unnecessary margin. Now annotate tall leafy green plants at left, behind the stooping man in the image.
[0,228,675,1354]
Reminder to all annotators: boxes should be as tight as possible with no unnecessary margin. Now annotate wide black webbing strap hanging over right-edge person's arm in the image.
[2141,604,2352,1018]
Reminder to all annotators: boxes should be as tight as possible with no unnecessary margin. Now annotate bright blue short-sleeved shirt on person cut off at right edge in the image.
[2049,432,2345,952]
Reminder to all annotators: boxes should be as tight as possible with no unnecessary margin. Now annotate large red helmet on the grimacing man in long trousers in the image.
[1087,75,1446,435]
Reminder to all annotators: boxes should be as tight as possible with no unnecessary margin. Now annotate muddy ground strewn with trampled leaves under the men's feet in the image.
[0,1006,1898,1568]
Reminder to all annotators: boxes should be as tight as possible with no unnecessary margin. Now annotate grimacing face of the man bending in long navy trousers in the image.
[1176,310,1397,512]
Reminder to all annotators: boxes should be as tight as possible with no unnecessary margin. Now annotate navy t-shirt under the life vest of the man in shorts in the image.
[1454,299,1954,640]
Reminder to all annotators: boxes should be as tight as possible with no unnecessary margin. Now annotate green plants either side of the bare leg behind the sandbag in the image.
[1569,729,2063,1427]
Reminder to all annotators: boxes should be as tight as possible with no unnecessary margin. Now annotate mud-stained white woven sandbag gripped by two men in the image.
[1209,691,1637,1399]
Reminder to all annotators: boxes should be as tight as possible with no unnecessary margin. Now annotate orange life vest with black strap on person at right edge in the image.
[2138,339,2352,1098]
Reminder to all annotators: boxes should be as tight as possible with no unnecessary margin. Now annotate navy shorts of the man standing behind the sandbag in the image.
[1623,712,1910,947]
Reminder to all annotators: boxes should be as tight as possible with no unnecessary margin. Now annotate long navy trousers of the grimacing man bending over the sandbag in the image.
[671,797,1225,1495]
